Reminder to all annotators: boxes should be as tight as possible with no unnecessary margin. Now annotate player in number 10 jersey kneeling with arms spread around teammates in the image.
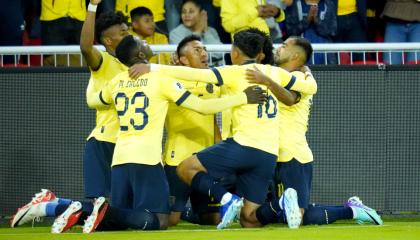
[139,31,316,228]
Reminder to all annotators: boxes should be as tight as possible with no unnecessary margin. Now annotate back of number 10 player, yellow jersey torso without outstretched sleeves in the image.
[218,64,279,155]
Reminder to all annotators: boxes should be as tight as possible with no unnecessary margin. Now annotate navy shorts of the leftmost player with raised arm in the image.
[83,138,115,198]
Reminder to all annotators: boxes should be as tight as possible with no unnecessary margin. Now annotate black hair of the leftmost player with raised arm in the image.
[95,12,128,43]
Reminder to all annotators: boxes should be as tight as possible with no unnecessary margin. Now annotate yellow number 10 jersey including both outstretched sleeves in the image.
[152,64,316,156]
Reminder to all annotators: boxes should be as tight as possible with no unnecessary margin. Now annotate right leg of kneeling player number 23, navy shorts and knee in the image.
[131,163,170,230]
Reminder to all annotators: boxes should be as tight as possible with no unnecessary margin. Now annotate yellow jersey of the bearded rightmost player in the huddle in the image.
[278,72,315,163]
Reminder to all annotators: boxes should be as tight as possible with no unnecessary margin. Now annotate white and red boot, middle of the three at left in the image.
[51,202,82,233]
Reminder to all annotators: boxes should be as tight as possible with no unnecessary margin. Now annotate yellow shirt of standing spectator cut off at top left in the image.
[40,0,86,21]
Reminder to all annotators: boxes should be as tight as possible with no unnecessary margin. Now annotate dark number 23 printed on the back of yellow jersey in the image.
[115,92,149,131]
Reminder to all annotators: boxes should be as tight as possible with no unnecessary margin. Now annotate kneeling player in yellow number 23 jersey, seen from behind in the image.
[85,35,265,229]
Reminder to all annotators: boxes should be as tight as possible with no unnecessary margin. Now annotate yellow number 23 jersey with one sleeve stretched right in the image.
[95,71,247,166]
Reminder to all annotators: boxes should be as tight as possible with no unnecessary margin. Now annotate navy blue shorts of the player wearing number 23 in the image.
[111,163,170,214]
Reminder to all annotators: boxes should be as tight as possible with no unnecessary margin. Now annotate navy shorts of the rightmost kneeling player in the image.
[274,159,313,209]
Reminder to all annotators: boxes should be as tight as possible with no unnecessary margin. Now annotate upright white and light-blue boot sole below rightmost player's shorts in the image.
[279,188,302,228]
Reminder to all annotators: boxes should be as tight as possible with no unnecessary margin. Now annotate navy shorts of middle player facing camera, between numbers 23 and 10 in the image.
[165,165,191,212]
